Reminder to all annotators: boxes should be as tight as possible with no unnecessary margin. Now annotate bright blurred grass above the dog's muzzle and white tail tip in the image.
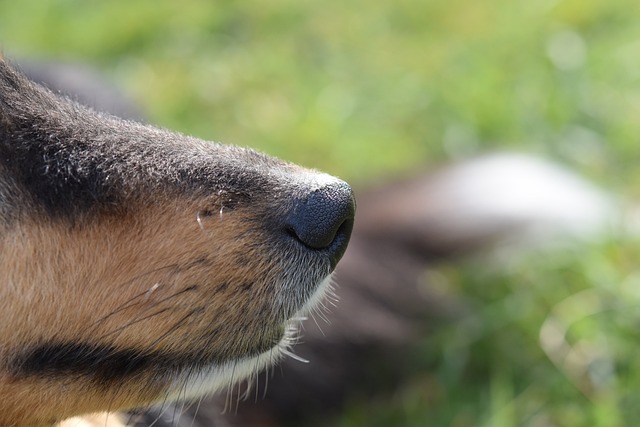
[0,0,640,191]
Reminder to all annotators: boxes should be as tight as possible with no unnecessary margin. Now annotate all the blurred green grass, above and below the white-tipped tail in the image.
[0,0,640,427]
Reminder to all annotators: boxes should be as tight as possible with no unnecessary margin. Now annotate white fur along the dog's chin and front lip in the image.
[162,275,333,403]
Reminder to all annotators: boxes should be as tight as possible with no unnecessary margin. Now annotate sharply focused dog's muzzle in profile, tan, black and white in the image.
[0,59,355,427]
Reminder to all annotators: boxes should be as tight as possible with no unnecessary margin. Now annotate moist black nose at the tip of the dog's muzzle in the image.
[286,180,356,265]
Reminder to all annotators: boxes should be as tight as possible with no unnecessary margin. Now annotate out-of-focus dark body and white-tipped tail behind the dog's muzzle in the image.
[13,61,617,427]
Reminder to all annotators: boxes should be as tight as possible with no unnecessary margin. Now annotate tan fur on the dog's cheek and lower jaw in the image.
[0,196,292,426]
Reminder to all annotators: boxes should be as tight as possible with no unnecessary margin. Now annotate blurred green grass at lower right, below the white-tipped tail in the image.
[329,239,640,427]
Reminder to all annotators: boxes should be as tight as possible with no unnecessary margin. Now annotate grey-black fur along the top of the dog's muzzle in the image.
[0,61,289,219]
